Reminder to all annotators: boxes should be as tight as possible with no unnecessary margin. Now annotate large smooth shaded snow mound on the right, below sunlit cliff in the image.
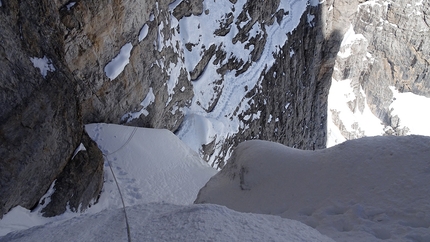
[196,136,430,241]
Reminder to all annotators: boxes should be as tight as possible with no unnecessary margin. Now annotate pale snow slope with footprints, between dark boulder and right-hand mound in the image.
[0,124,216,237]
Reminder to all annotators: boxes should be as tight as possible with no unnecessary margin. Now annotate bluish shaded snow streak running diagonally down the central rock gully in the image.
[177,0,308,164]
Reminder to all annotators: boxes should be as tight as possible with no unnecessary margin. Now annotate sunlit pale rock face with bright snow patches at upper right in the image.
[329,0,430,144]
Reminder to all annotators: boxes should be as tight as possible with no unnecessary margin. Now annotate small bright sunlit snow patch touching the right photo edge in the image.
[390,87,430,136]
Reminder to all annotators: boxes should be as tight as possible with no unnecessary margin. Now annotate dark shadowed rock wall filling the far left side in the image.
[0,1,102,217]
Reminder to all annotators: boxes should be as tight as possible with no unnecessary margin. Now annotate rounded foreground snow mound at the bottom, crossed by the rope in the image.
[0,203,333,242]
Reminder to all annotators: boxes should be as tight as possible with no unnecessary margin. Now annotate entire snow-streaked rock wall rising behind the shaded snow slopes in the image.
[0,0,429,216]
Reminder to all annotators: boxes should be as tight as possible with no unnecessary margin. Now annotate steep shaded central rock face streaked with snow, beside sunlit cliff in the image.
[177,1,342,168]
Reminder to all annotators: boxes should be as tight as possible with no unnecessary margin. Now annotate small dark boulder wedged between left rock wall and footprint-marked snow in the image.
[41,131,104,217]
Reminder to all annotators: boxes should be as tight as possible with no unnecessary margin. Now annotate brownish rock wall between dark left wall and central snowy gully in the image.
[59,0,194,130]
